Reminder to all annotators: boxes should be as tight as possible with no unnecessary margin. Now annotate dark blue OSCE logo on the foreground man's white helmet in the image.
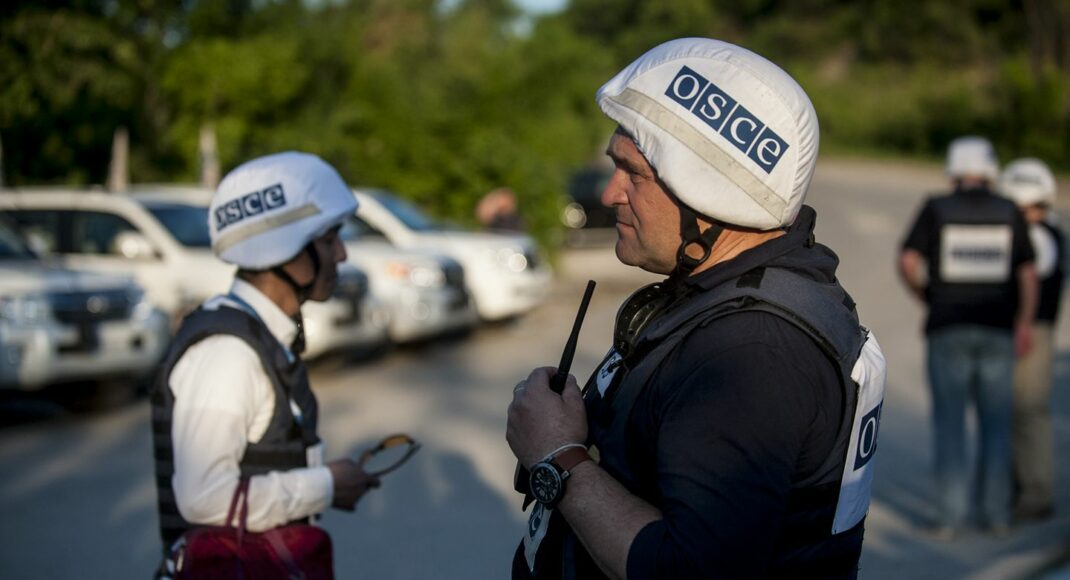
[666,66,788,173]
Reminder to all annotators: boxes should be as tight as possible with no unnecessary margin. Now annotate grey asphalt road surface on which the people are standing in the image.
[0,161,1070,580]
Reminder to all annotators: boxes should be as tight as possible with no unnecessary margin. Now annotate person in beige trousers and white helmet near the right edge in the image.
[999,158,1066,520]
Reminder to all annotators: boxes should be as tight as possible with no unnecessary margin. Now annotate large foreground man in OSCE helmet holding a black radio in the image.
[507,39,884,579]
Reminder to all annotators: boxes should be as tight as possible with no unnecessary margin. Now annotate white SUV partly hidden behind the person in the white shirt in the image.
[0,186,386,358]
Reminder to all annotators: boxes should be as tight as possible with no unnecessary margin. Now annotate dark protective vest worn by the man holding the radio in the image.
[514,266,886,579]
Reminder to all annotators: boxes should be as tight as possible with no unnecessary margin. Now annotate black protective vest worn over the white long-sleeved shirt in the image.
[151,306,320,553]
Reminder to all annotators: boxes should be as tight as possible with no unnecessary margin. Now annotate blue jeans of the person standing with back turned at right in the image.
[929,325,1014,528]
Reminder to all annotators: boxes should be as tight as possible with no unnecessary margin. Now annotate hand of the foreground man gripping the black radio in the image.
[505,367,587,469]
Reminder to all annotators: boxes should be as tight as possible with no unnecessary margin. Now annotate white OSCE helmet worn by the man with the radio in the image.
[597,39,820,230]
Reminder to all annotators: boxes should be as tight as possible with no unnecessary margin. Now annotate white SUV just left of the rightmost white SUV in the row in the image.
[341,215,478,344]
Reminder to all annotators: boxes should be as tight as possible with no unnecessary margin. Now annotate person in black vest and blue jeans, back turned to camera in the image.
[899,137,1037,539]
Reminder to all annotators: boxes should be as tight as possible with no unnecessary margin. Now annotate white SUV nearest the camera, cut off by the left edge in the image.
[0,216,170,391]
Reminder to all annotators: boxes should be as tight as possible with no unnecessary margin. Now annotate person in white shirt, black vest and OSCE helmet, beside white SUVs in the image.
[151,152,379,577]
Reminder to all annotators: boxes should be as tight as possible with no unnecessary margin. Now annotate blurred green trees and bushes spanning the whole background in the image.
[0,0,1070,254]
